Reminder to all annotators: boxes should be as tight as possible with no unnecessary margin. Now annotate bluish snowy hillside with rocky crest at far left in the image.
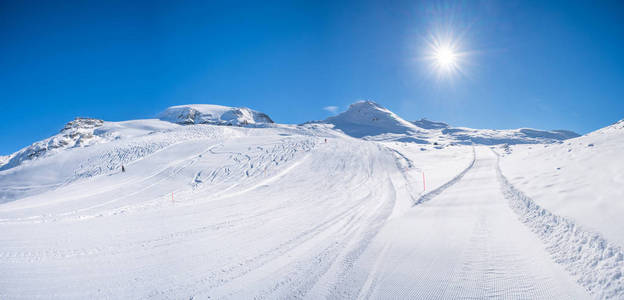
[0,119,185,203]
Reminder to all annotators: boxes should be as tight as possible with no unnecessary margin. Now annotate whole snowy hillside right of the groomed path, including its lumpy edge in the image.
[500,121,624,298]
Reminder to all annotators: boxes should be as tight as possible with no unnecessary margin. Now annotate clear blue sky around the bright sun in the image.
[0,0,624,154]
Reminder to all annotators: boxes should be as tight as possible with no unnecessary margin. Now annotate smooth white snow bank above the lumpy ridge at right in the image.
[501,121,624,246]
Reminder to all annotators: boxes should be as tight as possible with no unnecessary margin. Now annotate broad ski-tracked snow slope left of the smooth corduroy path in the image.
[0,127,471,299]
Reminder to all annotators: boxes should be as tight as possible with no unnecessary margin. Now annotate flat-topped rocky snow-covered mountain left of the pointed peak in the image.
[158,104,273,126]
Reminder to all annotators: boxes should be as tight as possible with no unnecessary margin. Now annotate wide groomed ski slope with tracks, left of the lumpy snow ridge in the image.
[0,125,622,299]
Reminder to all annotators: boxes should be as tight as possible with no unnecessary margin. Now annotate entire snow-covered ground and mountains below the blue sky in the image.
[0,102,624,299]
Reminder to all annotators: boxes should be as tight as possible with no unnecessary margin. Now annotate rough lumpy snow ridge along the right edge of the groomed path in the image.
[494,151,624,299]
